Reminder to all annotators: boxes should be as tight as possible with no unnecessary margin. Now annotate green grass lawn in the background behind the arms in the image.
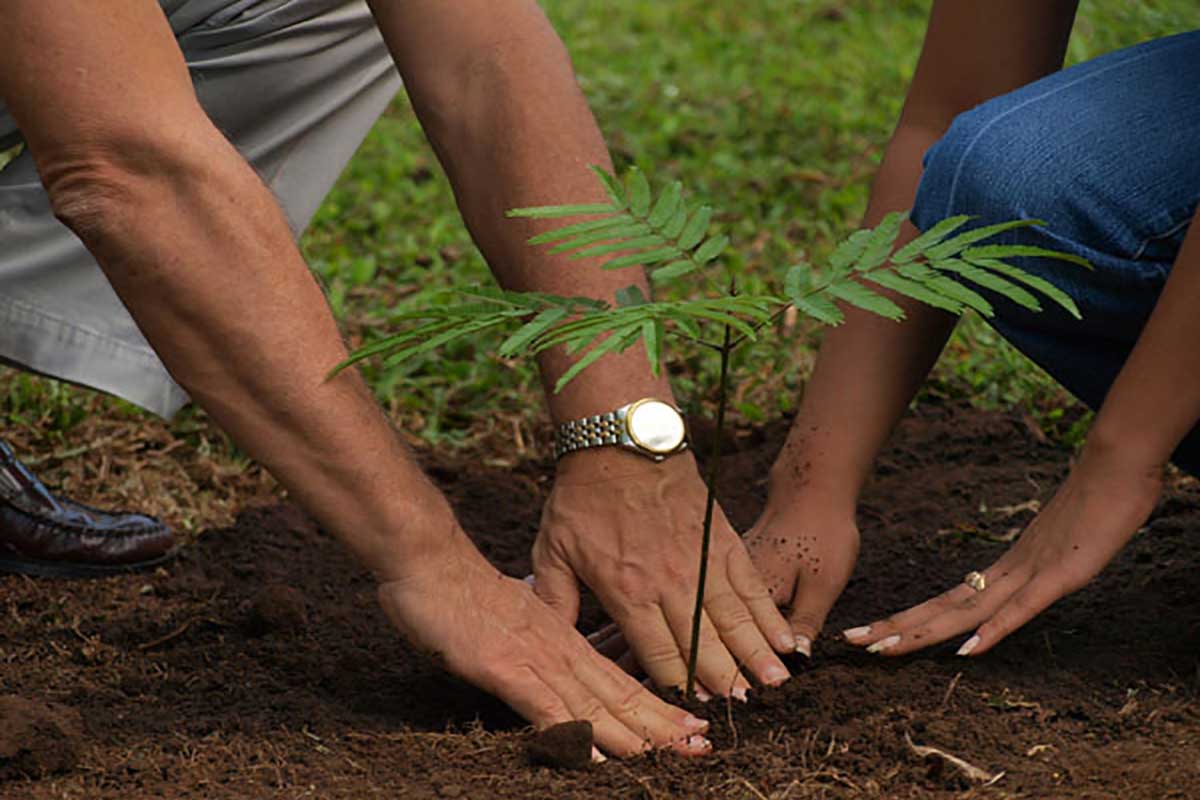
[5,0,1194,443]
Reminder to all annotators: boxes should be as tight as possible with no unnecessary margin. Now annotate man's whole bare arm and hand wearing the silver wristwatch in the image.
[372,0,794,694]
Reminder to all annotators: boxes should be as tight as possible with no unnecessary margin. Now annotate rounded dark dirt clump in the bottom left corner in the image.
[0,694,83,792]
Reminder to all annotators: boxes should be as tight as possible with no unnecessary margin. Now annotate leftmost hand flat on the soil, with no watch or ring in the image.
[379,525,712,756]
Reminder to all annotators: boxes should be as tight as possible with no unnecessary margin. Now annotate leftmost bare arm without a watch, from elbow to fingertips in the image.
[0,0,704,753]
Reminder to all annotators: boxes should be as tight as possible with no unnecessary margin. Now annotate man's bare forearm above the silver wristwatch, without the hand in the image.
[374,0,671,421]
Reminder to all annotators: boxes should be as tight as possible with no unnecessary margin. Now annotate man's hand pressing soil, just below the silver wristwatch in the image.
[533,451,796,697]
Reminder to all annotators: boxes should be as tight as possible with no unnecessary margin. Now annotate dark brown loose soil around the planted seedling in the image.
[0,404,1200,800]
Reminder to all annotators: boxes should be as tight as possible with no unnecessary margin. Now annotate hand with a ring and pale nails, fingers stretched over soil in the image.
[845,447,1163,656]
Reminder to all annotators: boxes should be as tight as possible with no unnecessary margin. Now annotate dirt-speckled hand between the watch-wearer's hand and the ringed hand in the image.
[745,498,859,656]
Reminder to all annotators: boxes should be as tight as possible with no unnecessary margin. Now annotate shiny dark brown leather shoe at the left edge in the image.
[0,441,175,577]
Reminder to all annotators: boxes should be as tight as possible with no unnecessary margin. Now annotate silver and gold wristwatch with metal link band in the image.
[554,397,688,461]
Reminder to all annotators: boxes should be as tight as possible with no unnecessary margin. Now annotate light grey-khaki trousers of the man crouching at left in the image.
[0,0,400,416]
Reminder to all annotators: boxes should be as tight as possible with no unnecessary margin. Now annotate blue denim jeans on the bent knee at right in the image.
[912,31,1200,473]
